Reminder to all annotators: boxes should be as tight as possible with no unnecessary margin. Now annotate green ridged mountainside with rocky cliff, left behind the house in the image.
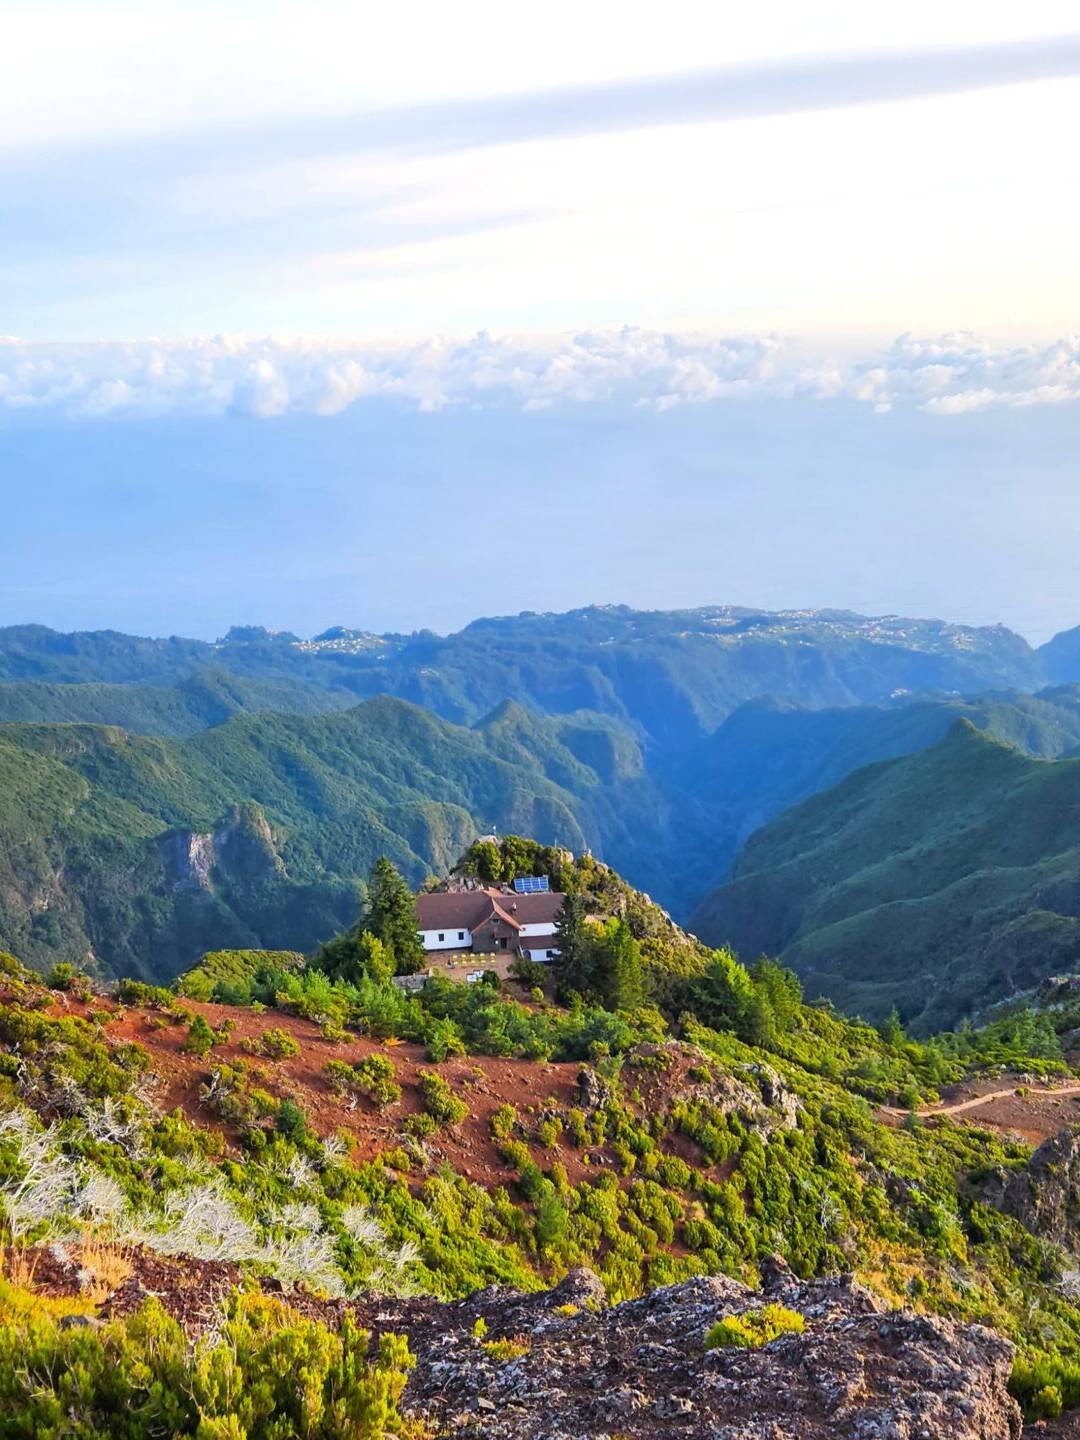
[0,698,612,976]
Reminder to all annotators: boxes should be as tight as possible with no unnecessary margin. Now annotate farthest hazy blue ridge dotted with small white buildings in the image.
[0,606,1054,743]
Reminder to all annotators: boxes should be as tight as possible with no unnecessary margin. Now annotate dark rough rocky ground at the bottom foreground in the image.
[37,1251,1025,1440]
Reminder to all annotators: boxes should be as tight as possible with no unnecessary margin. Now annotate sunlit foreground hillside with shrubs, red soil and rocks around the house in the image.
[0,838,1080,1440]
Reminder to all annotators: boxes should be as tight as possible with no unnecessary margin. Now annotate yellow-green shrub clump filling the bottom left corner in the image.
[0,1295,413,1440]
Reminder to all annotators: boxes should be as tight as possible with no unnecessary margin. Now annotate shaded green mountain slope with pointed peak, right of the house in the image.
[691,720,1080,1028]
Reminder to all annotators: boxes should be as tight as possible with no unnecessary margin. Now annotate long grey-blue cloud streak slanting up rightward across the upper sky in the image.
[0,35,1080,286]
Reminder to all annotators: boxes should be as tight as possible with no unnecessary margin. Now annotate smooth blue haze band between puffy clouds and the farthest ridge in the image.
[0,399,1080,641]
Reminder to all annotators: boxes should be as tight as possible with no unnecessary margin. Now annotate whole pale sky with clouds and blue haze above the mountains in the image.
[0,0,1080,639]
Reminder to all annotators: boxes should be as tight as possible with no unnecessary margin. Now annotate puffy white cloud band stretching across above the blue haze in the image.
[0,328,1080,419]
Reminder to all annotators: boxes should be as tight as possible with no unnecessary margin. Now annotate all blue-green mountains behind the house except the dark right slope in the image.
[0,608,1080,1001]
